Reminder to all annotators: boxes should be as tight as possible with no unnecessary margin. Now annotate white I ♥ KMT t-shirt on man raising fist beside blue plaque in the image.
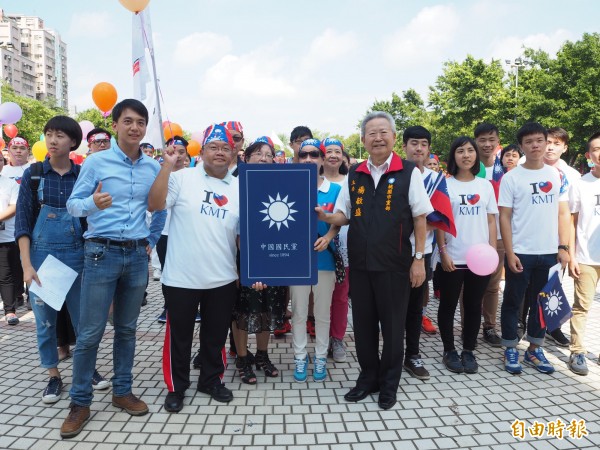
[161,164,240,289]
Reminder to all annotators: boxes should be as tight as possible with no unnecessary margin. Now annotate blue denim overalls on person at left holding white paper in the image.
[29,205,83,369]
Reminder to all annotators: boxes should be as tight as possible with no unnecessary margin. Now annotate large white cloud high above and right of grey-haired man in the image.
[383,5,460,67]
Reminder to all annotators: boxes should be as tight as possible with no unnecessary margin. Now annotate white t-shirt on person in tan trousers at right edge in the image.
[569,173,600,266]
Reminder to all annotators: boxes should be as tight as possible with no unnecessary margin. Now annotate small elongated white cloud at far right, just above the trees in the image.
[489,29,575,61]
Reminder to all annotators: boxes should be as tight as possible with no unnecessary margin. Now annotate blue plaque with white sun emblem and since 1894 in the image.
[238,164,318,286]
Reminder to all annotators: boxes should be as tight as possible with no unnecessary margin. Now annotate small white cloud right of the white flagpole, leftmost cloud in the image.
[173,32,232,66]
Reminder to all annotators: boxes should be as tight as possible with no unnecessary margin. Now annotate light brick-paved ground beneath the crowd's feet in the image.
[0,272,600,450]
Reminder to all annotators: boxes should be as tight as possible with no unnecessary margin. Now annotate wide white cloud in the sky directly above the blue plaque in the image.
[201,45,296,99]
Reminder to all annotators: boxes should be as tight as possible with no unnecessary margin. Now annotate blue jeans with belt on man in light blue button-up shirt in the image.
[70,241,148,406]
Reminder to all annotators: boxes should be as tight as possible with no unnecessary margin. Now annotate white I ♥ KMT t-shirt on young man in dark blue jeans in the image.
[498,165,569,255]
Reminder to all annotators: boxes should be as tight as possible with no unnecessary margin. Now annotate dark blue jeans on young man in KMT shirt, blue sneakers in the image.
[500,253,556,347]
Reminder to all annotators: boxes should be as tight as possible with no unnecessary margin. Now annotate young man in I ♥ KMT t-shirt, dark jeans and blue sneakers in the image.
[498,122,570,374]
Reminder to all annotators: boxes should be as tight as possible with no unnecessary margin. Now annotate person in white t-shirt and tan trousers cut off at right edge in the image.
[569,132,600,375]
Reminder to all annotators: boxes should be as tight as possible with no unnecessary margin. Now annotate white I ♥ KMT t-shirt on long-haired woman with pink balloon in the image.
[446,177,498,264]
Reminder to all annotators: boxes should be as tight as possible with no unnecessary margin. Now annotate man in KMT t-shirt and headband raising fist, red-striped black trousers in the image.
[148,125,239,412]
